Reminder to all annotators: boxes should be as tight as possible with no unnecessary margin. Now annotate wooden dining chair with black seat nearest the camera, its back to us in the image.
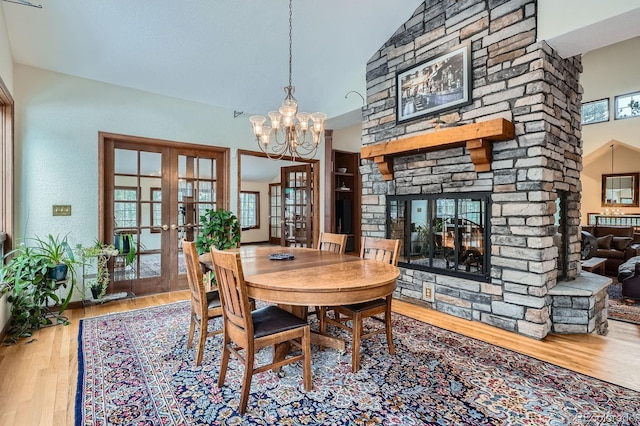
[211,248,311,414]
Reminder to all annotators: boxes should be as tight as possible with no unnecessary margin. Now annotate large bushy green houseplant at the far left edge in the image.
[0,235,76,344]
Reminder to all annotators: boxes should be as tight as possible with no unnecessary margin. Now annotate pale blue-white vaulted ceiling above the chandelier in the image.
[0,0,422,125]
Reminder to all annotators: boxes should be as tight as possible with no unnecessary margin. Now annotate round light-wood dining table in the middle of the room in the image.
[200,246,400,350]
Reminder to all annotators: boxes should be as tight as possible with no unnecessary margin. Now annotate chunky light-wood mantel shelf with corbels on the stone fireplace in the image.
[360,118,514,180]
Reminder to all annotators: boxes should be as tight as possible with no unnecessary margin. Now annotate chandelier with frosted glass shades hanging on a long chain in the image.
[249,0,327,159]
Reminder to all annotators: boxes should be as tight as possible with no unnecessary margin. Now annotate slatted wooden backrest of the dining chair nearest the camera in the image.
[211,247,253,349]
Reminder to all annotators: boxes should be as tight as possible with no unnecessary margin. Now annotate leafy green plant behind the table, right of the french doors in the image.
[196,208,240,254]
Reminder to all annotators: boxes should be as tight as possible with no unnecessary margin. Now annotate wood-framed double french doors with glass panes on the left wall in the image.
[99,134,229,295]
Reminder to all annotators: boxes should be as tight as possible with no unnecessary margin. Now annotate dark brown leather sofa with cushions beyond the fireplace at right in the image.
[582,226,640,277]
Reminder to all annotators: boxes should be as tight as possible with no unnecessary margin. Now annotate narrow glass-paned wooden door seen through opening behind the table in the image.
[280,164,314,247]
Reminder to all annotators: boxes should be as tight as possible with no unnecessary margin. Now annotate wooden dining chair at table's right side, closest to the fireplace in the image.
[319,237,401,373]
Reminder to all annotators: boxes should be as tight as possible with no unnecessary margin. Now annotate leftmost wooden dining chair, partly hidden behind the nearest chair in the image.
[182,240,222,365]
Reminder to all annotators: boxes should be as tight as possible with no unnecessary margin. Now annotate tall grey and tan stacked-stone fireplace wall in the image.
[360,0,582,339]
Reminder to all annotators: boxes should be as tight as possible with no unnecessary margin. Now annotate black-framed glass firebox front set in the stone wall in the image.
[387,193,490,280]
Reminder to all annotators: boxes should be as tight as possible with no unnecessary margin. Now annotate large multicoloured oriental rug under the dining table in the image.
[76,301,640,426]
